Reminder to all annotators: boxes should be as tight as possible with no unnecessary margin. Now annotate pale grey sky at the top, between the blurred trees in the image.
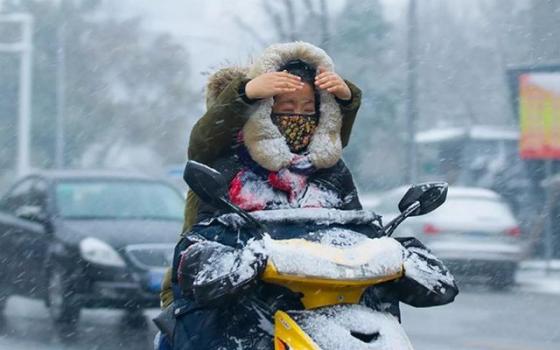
[110,0,406,86]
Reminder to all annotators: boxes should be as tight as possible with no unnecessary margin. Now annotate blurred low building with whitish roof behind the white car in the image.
[415,125,532,220]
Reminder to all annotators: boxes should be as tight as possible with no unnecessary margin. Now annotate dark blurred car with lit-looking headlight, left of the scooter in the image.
[0,170,184,332]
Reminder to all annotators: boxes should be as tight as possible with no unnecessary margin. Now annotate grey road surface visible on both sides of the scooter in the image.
[0,287,560,350]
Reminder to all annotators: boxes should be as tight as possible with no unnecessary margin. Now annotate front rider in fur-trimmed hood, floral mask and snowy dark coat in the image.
[155,43,457,350]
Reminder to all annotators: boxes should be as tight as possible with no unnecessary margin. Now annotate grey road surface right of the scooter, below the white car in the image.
[403,287,560,350]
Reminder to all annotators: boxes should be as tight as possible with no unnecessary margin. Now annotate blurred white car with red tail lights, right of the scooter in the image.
[366,186,526,288]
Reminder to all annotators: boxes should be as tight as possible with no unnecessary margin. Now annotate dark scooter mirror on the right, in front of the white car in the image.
[399,182,448,216]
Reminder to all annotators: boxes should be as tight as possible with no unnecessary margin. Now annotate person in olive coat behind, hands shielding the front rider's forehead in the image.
[161,41,362,308]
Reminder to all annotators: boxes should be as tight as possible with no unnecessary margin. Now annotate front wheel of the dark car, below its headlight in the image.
[47,264,81,339]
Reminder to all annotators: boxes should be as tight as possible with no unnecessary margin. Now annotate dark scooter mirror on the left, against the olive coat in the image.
[183,160,228,208]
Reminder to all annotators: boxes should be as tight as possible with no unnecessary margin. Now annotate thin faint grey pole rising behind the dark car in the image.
[55,22,66,169]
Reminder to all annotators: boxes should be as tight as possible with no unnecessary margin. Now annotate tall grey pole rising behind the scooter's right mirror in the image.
[406,0,418,184]
